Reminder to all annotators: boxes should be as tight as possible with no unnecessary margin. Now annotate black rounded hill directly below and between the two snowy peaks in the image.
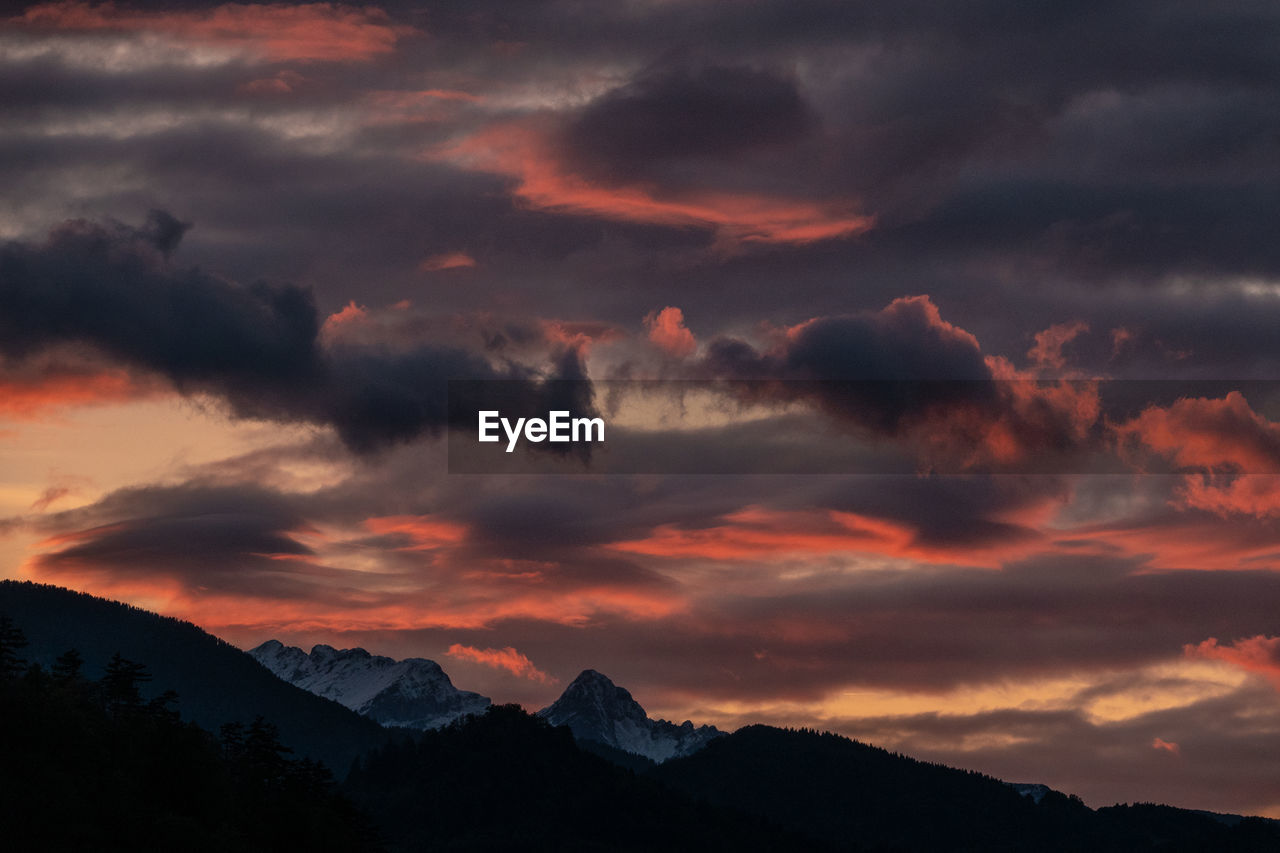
[343,706,822,853]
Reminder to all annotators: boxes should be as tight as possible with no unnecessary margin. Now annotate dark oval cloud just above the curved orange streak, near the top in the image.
[563,65,815,181]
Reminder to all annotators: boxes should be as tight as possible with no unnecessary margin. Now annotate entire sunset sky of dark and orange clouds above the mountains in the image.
[0,0,1280,817]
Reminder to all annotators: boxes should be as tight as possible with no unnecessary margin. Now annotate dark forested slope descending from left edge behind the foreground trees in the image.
[0,580,388,777]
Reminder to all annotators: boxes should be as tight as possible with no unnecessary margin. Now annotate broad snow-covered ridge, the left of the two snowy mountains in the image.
[250,639,489,729]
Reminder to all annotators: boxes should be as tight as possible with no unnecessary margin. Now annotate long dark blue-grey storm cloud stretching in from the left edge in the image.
[0,211,590,451]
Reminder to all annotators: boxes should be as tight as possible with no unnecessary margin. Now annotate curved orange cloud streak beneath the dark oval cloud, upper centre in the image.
[425,122,874,243]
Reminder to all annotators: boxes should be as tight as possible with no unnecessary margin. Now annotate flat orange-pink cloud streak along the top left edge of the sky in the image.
[9,0,415,61]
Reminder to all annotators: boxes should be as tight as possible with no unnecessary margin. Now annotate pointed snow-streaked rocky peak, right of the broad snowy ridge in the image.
[538,670,724,762]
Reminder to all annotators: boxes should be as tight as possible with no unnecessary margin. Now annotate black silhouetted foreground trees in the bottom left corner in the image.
[0,617,380,853]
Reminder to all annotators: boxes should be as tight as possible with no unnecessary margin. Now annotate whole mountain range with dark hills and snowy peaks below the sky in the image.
[0,581,1280,853]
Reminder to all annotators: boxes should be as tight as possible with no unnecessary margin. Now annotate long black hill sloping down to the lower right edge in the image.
[646,726,1280,853]
